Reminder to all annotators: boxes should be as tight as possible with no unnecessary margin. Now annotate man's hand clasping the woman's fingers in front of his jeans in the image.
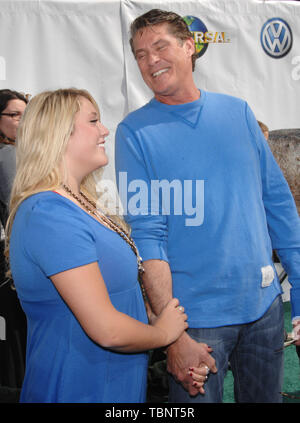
[167,332,217,396]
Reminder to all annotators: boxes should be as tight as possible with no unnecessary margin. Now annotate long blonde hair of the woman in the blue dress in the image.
[5,88,125,274]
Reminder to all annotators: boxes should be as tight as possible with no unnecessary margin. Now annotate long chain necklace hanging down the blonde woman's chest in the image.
[62,184,146,301]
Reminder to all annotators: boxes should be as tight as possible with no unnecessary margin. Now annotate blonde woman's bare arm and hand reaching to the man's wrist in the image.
[51,262,188,352]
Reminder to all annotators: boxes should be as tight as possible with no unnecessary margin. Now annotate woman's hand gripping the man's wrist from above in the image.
[153,298,188,345]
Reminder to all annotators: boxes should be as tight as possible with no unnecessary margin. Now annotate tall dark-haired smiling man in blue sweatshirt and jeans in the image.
[116,9,300,402]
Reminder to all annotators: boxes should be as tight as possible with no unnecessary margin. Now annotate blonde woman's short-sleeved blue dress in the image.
[10,192,147,403]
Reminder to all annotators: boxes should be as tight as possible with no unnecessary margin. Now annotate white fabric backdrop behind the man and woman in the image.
[0,0,300,179]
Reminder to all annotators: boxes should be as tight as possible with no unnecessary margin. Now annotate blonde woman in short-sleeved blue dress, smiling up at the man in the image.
[7,89,197,403]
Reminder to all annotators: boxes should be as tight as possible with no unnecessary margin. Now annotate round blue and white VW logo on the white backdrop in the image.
[260,18,293,59]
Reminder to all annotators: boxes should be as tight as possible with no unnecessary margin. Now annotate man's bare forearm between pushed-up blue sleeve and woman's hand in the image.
[143,260,173,315]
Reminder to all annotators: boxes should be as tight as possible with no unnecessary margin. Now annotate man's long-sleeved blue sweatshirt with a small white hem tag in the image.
[116,91,300,328]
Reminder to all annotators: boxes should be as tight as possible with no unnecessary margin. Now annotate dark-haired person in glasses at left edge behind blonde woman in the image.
[0,89,28,402]
